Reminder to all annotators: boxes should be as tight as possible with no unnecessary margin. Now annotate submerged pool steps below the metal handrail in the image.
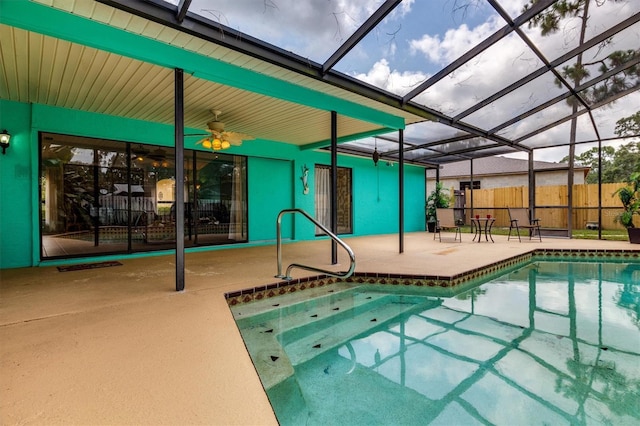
[232,286,440,389]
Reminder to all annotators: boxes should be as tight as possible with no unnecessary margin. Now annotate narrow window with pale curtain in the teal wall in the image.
[315,165,353,235]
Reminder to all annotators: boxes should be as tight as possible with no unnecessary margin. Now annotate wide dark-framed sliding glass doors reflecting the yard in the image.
[40,133,248,259]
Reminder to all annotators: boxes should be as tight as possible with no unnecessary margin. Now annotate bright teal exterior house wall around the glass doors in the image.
[0,100,425,268]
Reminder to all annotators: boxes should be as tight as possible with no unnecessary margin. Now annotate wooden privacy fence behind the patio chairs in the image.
[460,183,640,229]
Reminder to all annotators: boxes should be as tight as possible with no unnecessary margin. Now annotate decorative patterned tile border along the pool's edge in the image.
[225,249,640,306]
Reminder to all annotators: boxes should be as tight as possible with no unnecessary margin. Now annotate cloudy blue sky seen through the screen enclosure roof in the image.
[173,0,640,161]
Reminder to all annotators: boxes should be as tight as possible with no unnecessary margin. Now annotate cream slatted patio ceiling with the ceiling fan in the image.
[1,20,380,145]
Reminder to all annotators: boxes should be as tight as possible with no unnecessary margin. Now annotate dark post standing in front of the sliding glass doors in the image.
[174,68,184,291]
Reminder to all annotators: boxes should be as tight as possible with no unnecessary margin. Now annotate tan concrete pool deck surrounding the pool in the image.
[0,232,640,425]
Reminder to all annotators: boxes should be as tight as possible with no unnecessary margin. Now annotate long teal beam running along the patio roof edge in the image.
[0,0,405,129]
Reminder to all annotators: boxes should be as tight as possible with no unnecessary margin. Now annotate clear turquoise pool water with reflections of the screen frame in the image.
[232,262,640,425]
